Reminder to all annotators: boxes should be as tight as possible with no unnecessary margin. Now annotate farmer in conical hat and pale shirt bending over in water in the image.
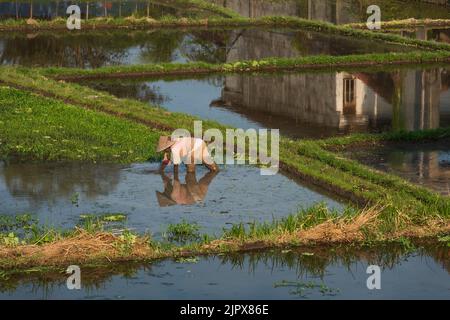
[156,136,219,172]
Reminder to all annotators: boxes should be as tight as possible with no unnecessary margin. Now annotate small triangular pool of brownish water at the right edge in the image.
[346,140,450,196]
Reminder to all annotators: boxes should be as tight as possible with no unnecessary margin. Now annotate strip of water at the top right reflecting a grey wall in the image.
[214,0,450,24]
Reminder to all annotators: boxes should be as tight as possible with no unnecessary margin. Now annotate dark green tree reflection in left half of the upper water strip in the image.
[0,30,232,68]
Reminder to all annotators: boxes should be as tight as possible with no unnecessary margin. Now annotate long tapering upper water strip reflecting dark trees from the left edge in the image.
[0,29,406,68]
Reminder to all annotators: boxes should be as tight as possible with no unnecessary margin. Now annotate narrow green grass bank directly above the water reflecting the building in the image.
[37,51,450,80]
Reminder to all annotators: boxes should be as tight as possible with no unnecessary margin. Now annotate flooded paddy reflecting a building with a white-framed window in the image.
[84,67,450,138]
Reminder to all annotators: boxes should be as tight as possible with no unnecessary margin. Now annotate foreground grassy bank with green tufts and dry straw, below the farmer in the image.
[0,205,450,270]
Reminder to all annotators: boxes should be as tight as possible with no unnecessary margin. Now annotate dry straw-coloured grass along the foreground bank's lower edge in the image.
[0,206,450,269]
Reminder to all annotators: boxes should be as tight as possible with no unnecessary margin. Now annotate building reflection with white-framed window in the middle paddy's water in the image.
[222,69,441,135]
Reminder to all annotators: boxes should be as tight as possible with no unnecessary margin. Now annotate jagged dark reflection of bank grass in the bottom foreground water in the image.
[0,238,449,292]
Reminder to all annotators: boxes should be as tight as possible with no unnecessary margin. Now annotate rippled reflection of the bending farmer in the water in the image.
[156,171,217,207]
